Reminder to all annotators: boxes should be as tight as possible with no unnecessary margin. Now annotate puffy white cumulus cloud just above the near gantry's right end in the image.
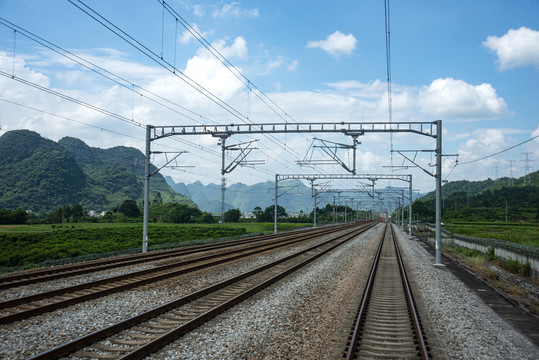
[418,78,508,121]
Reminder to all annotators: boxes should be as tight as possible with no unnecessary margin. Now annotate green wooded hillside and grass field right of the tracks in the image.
[405,171,539,247]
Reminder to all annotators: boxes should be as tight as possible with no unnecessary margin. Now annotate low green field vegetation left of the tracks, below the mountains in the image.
[0,224,247,268]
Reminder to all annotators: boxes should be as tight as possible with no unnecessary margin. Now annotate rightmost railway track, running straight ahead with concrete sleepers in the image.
[346,225,431,359]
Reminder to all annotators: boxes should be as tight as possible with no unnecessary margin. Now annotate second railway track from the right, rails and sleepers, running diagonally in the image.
[28,224,375,360]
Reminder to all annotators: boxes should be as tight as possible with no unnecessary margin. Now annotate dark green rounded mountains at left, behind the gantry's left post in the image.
[0,130,196,211]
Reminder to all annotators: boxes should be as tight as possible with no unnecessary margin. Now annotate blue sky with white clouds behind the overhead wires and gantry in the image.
[0,0,539,198]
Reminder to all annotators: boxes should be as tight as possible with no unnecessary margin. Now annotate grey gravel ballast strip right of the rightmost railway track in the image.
[395,227,539,359]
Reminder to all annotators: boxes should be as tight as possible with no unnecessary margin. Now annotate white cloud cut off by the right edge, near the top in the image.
[482,27,539,70]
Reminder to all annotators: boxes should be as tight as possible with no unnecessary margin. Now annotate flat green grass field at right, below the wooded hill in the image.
[444,222,539,247]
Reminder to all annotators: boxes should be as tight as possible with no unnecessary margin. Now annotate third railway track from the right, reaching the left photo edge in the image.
[0,222,358,325]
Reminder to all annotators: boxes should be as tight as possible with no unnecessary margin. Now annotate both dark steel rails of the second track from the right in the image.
[30,223,375,360]
